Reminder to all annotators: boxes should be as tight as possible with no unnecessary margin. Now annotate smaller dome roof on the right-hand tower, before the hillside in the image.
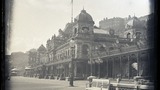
[125,17,145,29]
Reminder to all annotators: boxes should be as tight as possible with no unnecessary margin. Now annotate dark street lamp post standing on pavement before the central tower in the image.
[69,38,75,87]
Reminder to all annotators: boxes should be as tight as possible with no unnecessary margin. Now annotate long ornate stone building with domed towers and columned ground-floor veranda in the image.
[29,10,152,79]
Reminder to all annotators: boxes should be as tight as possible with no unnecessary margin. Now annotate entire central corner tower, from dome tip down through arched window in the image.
[72,9,94,60]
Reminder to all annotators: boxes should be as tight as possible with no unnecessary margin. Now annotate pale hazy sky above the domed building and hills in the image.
[8,0,151,53]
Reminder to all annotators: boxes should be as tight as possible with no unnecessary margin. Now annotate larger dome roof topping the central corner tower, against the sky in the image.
[75,9,94,24]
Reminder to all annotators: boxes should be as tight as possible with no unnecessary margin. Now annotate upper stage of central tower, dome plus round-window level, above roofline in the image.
[73,9,94,38]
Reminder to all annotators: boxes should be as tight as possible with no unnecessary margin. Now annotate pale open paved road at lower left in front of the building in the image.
[6,76,88,90]
